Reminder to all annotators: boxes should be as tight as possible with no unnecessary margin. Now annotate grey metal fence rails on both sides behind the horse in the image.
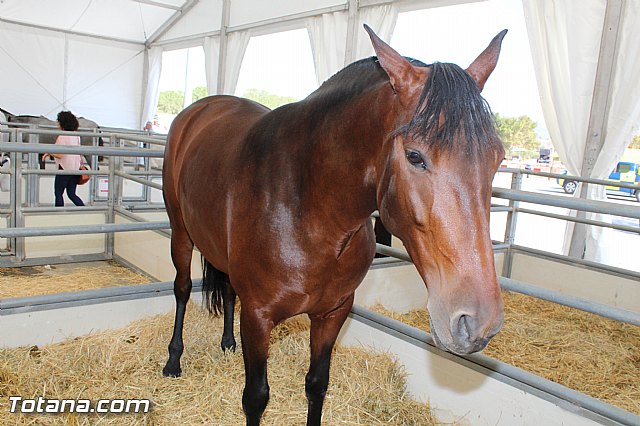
[0,123,640,272]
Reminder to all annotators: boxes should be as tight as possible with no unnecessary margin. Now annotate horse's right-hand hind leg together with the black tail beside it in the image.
[202,256,236,352]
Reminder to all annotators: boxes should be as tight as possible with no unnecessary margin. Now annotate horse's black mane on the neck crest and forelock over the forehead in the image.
[309,56,501,154]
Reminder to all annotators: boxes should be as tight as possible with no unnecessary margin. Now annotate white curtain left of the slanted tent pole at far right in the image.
[523,0,606,175]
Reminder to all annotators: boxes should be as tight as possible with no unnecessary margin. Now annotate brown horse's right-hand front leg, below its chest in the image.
[305,295,353,425]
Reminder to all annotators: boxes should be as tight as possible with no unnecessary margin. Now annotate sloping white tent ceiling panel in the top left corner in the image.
[0,0,194,43]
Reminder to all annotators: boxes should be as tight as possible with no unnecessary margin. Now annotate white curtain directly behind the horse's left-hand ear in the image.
[356,3,398,59]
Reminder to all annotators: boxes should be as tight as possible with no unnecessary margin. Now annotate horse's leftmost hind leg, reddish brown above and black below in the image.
[162,229,193,377]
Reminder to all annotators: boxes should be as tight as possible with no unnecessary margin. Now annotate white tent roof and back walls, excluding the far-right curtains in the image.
[0,0,470,129]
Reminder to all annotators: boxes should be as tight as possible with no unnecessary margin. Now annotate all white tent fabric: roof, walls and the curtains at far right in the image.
[0,0,640,258]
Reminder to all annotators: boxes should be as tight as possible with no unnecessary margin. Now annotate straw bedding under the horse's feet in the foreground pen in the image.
[0,304,435,426]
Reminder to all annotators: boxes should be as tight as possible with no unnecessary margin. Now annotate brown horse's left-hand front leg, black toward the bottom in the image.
[240,306,274,426]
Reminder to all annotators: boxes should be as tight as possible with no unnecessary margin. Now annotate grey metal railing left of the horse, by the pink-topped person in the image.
[0,126,169,266]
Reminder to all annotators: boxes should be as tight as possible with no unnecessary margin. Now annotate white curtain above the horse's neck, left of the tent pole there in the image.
[306,12,348,85]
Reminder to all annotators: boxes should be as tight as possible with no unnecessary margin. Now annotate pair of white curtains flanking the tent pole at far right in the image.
[523,0,640,261]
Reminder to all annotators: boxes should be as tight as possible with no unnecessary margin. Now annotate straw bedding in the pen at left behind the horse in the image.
[0,261,151,299]
